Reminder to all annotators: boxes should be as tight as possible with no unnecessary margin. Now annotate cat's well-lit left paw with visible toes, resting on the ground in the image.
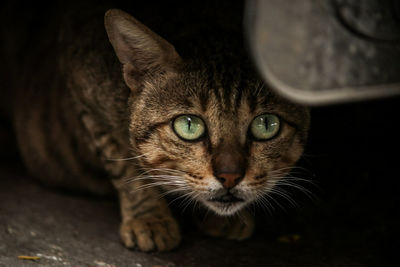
[120,215,181,252]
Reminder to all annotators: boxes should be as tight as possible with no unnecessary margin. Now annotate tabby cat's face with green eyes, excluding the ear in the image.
[131,67,309,215]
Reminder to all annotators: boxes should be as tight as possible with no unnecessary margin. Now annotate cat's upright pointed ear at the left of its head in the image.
[104,9,180,90]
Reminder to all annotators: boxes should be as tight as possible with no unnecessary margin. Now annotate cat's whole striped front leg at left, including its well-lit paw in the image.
[83,115,181,251]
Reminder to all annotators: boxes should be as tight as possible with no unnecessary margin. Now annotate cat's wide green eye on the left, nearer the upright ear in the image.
[173,115,206,141]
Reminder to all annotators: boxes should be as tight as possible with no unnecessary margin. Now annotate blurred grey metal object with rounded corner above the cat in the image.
[245,0,400,105]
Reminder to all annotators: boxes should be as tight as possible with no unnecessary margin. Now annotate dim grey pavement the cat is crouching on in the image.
[0,161,394,267]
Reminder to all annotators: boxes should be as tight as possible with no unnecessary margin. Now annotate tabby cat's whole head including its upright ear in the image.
[105,10,309,215]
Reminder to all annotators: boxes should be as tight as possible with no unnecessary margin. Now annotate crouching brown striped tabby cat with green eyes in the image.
[7,6,310,251]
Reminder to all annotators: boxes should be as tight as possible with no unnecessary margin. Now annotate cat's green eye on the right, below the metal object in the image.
[250,114,280,140]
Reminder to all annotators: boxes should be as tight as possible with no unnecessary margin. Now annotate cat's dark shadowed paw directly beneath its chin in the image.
[196,211,255,240]
